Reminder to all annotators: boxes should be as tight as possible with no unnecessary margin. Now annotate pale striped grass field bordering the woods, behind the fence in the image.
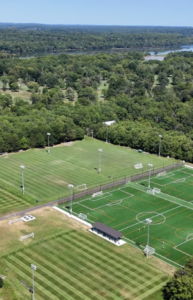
[0,138,174,212]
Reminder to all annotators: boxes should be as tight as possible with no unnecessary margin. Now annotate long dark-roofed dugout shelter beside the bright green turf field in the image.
[91,222,123,243]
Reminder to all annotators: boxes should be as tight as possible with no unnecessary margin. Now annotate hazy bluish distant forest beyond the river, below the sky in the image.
[0,23,193,56]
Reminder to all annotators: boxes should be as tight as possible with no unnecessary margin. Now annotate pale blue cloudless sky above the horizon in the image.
[0,0,193,26]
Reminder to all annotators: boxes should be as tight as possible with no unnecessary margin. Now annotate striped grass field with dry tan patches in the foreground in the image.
[0,208,170,300]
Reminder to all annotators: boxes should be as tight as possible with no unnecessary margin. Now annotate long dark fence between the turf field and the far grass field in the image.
[58,163,183,204]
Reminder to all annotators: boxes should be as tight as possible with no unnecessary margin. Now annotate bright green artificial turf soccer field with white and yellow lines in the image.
[60,166,193,267]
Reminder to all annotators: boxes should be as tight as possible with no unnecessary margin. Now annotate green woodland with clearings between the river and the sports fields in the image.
[0,52,193,162]
